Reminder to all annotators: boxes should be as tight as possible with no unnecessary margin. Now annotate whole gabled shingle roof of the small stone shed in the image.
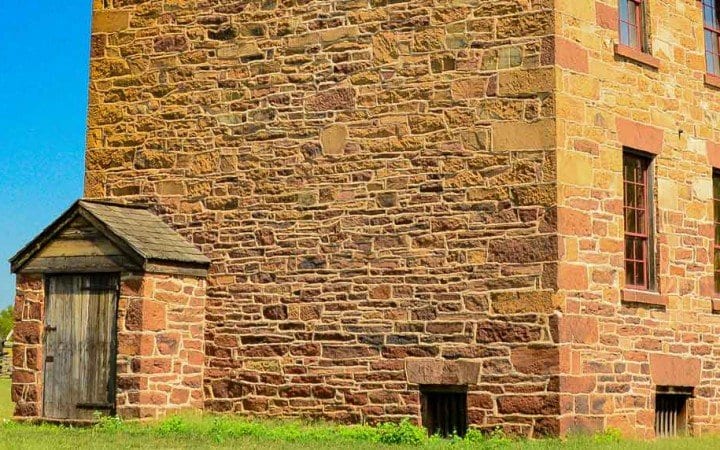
[10,199,210,272]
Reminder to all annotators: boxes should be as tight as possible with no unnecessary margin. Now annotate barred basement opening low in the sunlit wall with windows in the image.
[655,386,692,438]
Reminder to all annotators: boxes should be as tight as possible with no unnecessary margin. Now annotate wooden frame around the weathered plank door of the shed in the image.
[40,272,122,422]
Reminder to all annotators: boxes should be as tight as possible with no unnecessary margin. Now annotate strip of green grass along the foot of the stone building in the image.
[0,380,720,450]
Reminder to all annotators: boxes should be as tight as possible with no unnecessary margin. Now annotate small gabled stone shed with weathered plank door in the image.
[10,200,210,421]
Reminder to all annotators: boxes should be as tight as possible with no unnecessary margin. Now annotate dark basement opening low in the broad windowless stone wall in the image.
[420,386,468,437]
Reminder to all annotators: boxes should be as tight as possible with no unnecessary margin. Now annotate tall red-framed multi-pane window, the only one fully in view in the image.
[623,151,654,289]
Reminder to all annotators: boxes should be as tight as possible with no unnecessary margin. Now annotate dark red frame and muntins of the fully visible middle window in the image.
[622,147,657,291]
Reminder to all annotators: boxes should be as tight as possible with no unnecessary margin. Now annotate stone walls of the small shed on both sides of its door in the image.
[12,274,205,419]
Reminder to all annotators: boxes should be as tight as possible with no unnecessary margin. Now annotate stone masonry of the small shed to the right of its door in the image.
[117,274,205,419]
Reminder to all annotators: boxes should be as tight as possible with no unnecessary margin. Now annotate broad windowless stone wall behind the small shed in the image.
[86,0,559,434]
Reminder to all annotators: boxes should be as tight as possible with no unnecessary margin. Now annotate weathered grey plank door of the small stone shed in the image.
[43,274,118,420]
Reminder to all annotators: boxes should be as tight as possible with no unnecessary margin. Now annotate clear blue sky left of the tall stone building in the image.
[0,0,92,307]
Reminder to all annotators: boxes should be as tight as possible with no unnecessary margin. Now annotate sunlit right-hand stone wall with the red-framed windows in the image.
[556,0,720,437]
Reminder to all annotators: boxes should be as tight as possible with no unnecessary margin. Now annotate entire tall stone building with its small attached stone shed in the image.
[13,0,720,437]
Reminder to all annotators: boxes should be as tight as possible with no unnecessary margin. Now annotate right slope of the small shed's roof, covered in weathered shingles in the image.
[79,200,210,264]
